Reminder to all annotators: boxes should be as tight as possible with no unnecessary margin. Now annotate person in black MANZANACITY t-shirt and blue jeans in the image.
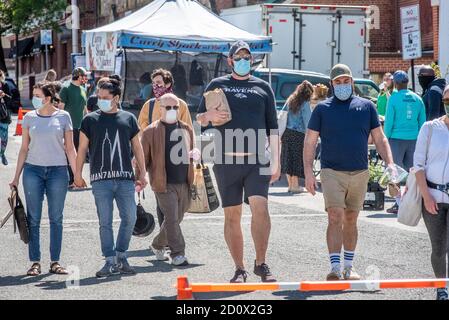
[75,79,147,278]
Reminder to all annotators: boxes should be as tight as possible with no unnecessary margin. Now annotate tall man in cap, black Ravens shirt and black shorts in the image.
[197,41,280,283]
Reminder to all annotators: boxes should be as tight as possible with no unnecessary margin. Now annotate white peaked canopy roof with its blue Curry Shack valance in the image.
[86,0,271,53]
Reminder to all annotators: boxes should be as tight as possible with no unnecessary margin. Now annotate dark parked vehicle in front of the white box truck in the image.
[254,68,380,109]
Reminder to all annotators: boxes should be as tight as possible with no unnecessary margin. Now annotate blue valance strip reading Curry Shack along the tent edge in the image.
[118,33,272,53]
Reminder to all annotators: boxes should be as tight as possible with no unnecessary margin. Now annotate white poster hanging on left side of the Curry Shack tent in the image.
[86,32,117,71]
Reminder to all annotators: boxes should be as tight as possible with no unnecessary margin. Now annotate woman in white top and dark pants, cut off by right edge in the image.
[414,86,449,300]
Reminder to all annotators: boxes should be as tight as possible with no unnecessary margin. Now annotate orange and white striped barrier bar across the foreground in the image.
[176,276,449,300]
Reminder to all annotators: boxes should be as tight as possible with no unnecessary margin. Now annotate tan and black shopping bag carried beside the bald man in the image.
[188,164,220,213]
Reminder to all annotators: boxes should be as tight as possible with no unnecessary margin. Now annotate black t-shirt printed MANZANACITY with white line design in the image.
[81,110,139,183]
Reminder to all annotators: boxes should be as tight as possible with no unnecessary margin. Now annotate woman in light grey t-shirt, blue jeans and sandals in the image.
[10,83,76,276]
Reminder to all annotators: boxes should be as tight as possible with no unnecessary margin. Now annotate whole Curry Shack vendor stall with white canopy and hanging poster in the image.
[83,0,272,111]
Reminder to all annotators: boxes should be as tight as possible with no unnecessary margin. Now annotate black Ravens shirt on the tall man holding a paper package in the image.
[198,75,278,161]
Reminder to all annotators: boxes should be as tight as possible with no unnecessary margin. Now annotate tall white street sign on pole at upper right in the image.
[401,5,422,60]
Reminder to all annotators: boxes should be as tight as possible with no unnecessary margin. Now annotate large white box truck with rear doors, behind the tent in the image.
[221,4,371,78]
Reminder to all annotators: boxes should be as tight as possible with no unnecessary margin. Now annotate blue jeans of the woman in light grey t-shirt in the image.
[23,163,69,261]
